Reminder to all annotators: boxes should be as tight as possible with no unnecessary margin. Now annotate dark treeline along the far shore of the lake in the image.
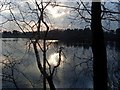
[1,28,120,42]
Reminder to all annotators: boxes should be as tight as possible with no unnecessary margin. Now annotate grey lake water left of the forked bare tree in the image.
[2,39,41,88]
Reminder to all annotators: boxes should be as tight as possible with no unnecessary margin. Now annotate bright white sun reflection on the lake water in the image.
[48,53,64,66]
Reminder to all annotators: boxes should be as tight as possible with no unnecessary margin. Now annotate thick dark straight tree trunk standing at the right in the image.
[91,0,107,90]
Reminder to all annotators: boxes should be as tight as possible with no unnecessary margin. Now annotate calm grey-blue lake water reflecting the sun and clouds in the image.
[2,39,120,88]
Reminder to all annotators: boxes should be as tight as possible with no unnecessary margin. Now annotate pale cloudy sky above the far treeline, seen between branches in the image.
[0,0,118,31]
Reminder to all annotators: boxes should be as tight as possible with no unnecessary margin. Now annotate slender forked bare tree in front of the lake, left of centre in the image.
[0,0,62,90]
